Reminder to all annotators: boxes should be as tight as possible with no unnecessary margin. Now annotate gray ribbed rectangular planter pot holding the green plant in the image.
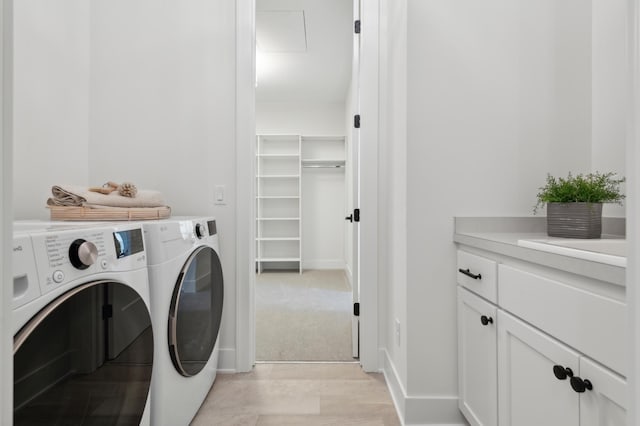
[547,203,602,238]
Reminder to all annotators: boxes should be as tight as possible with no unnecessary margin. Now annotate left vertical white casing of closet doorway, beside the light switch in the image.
[236,0,256,372]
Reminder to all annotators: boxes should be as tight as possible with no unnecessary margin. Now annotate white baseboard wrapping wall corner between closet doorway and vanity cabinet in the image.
[383,350,468,426]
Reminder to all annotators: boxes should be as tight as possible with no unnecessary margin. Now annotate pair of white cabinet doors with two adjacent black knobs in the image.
[498,311,627,426]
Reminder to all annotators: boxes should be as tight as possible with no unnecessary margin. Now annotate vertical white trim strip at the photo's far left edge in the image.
[0,0,13,425]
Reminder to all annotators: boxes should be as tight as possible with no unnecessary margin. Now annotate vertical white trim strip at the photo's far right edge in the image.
[626,0,640,425]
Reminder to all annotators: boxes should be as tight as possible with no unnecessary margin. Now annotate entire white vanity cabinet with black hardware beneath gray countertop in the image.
[457,250,627,426]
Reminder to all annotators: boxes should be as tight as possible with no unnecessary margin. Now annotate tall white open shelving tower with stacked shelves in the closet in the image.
[256,135,302,273]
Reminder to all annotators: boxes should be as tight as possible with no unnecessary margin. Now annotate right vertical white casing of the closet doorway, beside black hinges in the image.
[354,0,380,371]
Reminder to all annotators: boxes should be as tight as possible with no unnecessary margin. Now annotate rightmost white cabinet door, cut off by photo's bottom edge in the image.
[579,358,627,426]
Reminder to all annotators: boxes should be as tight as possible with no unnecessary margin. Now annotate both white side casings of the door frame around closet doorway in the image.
[235,0,380,372]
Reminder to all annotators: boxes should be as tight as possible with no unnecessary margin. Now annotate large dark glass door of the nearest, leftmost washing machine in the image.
[13,281,153,426]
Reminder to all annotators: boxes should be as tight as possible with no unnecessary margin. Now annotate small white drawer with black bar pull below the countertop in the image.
[457,250,497,303]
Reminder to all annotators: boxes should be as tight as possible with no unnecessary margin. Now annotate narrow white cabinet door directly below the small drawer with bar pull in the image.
[458,287,498,426]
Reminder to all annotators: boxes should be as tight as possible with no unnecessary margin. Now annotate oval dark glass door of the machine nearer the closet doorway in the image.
[169,246,224,377]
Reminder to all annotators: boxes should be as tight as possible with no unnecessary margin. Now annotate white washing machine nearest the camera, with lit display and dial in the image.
[12,222,154,425]
